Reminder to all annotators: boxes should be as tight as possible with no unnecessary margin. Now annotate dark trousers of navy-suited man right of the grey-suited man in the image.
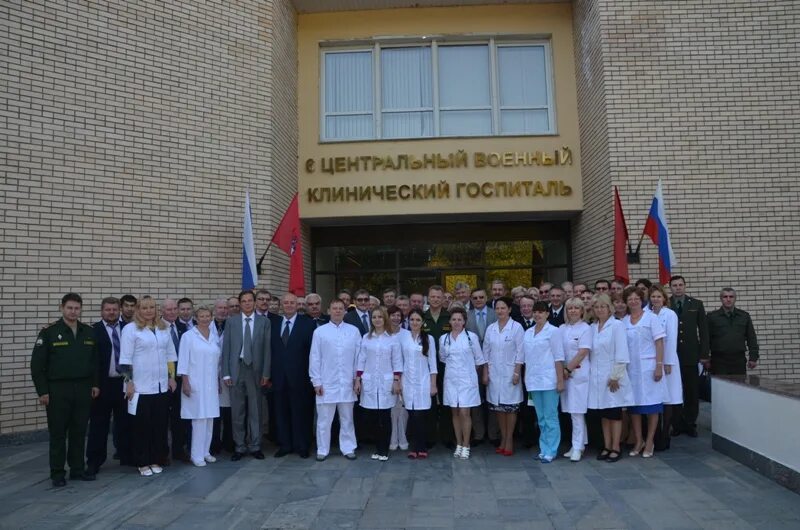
[272,384,314,453]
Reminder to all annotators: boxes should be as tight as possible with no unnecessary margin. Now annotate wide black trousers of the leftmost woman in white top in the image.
[133,392,169,467]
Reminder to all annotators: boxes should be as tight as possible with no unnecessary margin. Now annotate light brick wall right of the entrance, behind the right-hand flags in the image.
[575,0,800,380]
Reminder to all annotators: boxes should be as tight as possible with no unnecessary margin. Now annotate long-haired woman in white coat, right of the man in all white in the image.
[355,307,403,462]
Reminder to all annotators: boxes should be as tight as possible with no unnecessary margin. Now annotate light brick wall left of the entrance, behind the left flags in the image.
[0,0,297,434]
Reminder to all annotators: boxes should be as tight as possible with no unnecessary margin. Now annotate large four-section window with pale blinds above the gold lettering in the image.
[321,39,555,141]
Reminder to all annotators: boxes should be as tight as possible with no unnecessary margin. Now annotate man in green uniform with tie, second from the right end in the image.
[669,275,709,437]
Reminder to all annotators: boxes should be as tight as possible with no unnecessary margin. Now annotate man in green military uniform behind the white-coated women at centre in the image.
[422,285,455,449]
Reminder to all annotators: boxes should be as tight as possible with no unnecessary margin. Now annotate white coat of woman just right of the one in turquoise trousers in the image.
[558,320,592,414]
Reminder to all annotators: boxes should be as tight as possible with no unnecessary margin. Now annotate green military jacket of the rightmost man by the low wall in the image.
[708,307,758,375]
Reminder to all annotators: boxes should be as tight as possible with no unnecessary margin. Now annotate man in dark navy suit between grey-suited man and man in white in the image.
[271,293,316,458]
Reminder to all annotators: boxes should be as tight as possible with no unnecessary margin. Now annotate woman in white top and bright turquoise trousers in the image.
[522,302,564,464]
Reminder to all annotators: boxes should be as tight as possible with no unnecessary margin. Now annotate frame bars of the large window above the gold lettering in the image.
[319,37,558,143]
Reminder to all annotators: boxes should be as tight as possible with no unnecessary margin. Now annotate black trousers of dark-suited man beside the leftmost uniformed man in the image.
[86,377,134,470]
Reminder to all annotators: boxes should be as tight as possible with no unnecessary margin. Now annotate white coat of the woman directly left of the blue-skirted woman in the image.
[589,318,633,409]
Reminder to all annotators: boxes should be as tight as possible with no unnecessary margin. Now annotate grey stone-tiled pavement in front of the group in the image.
[0,418,800,530]
